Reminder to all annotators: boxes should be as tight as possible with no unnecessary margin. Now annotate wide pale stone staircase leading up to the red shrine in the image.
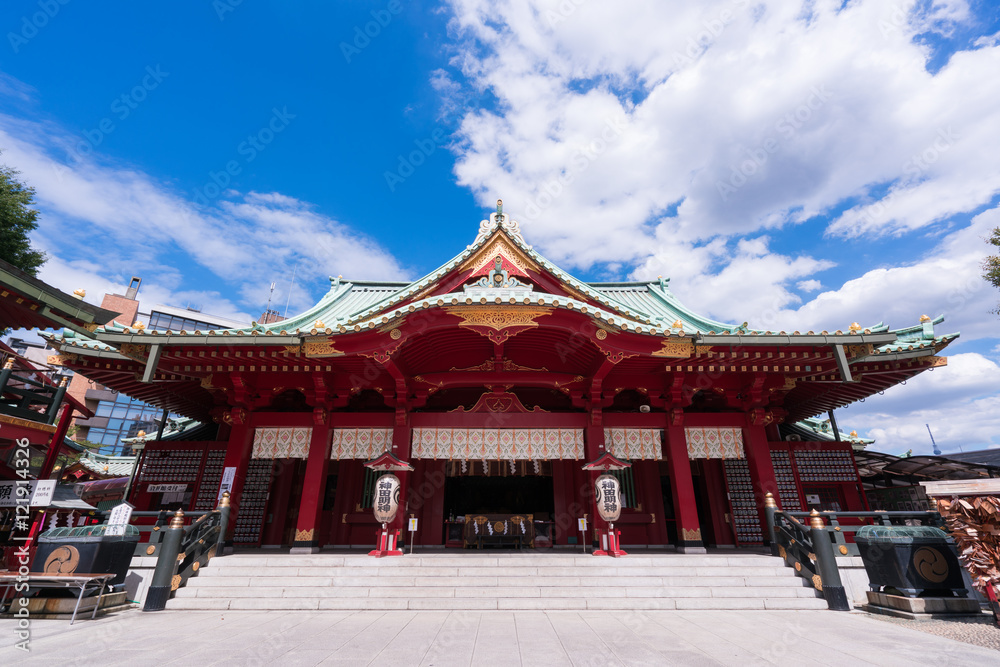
[167,552,827,610]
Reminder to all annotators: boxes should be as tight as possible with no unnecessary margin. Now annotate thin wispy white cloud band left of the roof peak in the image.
[0,111,405,321]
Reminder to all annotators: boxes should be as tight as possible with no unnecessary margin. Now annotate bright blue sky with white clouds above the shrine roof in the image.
[0,0,1000,452]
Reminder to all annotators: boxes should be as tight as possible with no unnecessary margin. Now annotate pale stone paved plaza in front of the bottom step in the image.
[0,610,1000,667]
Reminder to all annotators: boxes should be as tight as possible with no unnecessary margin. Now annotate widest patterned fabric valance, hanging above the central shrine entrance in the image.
[411,428,583,461]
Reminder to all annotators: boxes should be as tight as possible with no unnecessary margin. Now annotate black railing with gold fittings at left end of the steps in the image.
[141,491,229,611]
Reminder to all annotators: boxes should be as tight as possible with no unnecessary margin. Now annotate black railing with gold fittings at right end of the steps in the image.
[764,493,944,611]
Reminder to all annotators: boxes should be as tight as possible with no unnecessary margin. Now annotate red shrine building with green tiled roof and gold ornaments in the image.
[43,206,957,552]
